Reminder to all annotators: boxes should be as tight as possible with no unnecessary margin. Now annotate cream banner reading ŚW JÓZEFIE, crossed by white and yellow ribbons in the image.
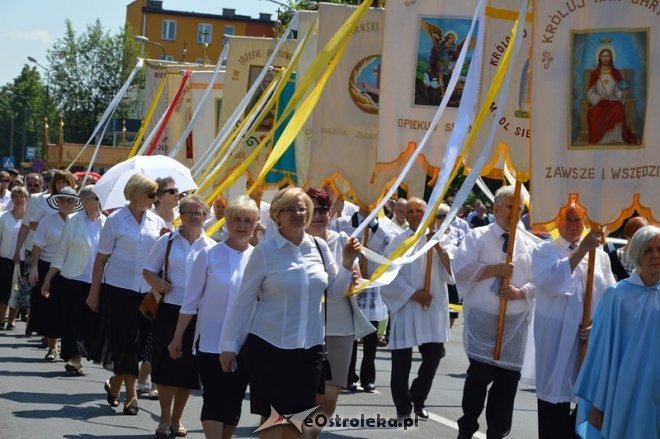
[220,36,296,187]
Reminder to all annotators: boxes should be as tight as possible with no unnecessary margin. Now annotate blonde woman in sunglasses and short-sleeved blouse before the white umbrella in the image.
[87,174,165,415]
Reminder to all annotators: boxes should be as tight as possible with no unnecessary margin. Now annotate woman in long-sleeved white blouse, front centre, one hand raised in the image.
[220,188,360,437]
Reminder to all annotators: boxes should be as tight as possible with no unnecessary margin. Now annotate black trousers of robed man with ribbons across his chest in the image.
[390,343,445,415]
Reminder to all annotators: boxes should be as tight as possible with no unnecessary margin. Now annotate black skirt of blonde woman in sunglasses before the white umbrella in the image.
[91,284,150,377]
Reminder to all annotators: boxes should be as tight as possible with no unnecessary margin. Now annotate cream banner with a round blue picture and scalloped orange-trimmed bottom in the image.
[308,3,385,203]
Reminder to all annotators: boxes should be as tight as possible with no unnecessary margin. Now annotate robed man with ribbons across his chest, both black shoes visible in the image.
[381,198,454,419]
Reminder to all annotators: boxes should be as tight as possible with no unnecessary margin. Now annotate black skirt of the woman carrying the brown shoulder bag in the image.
[151,302,200,389]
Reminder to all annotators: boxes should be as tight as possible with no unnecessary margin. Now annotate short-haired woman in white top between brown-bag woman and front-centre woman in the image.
[169,196,259,439]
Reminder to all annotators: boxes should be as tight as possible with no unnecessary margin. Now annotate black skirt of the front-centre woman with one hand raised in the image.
[246,334,323,417]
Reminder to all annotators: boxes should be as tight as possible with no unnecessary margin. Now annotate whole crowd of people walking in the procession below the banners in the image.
[0,167,660,439]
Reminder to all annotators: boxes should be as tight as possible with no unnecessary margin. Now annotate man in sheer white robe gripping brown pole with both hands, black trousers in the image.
[452,186,536,438]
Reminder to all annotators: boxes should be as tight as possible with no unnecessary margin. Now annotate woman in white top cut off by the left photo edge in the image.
[0,187,28,330]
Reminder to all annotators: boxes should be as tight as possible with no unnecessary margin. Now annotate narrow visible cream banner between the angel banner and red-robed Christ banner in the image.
[464,0,533,181]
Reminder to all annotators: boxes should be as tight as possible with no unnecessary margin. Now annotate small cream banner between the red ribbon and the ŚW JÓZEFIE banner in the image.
[185,71,225,168]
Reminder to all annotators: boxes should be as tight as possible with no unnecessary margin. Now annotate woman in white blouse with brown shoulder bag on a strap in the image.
[143,195,215,437]
